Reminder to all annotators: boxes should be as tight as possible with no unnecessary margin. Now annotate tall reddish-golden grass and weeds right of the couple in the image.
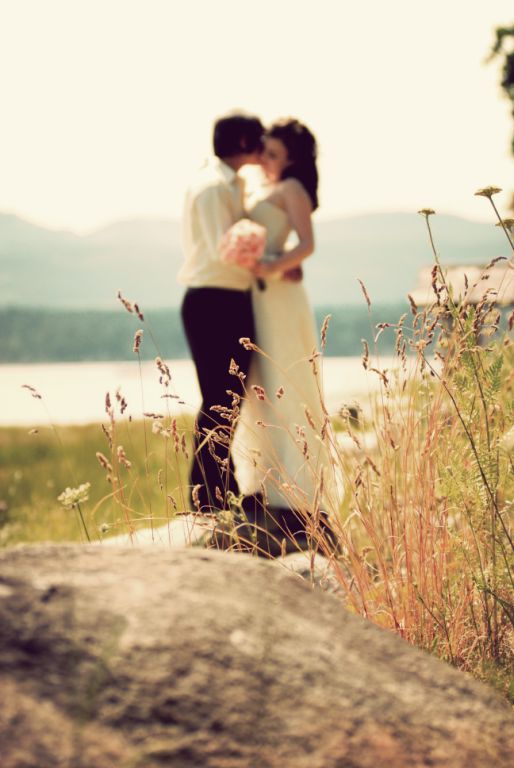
[312,192,514,696]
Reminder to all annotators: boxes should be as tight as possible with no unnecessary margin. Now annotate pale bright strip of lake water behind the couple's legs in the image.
[0,357,392,427]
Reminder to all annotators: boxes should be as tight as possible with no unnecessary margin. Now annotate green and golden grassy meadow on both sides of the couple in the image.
[0,189,514,701]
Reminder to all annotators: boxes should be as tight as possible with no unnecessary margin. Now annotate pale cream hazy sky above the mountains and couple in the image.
[0,0,514,231]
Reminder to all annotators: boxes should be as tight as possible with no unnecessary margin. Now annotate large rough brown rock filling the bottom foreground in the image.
[0,545,514,768]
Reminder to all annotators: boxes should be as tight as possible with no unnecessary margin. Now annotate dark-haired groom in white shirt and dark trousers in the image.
[178,114,264,512]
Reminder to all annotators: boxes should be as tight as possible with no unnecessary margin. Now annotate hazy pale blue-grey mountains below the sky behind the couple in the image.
[0,213,508,309]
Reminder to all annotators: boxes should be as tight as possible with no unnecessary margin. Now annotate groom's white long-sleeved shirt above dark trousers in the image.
[178,157,252,291]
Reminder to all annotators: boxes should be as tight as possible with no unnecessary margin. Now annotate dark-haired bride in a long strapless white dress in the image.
[235,119,336,540]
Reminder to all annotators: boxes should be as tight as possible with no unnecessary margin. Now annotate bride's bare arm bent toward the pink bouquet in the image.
[255,179,314,277]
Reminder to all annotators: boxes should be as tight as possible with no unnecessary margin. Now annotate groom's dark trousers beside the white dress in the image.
[182,287,255,512]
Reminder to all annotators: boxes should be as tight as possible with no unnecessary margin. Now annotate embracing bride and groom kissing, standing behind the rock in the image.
[178,113,330,556]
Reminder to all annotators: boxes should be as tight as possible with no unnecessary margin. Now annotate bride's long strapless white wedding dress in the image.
[233,200,329,509]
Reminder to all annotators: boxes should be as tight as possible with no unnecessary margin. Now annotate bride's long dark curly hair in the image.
[266,117,318,211]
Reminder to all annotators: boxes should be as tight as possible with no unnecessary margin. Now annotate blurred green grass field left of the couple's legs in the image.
[0,419,190,546]
